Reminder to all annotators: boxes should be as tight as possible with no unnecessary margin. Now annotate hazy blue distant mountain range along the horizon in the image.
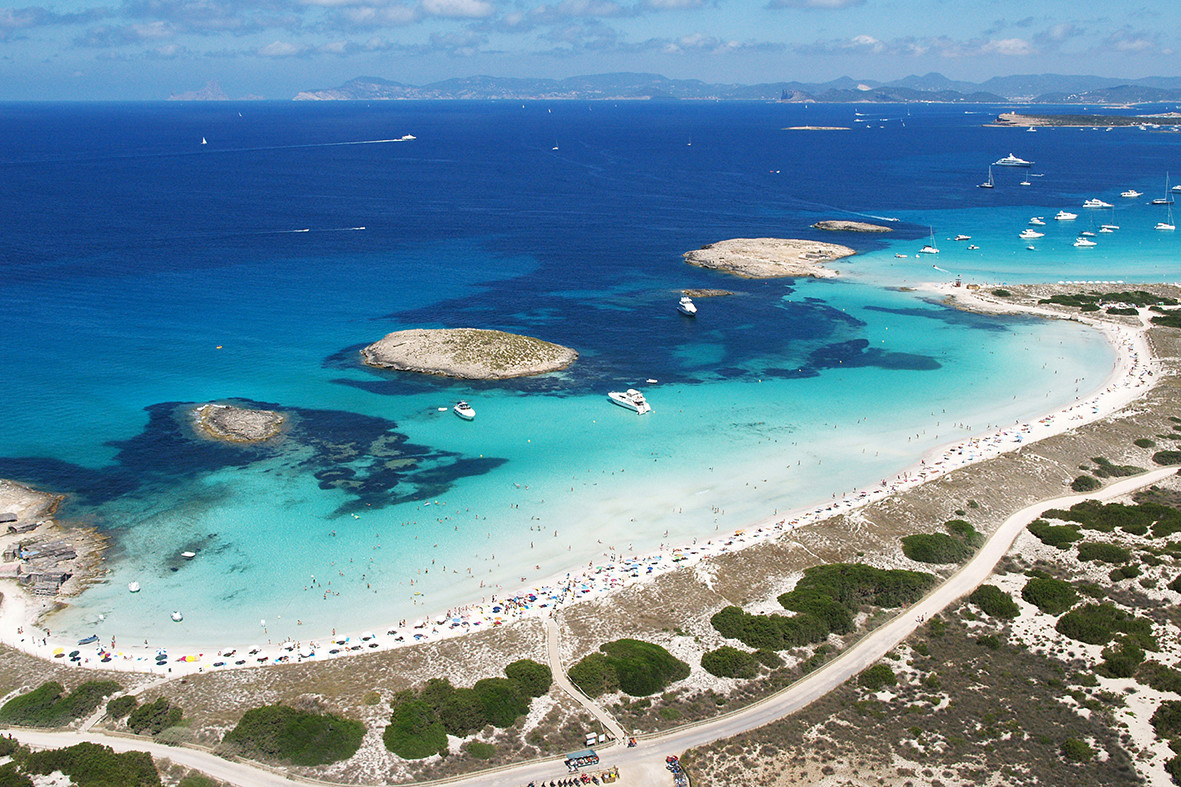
[288,73,1181,105]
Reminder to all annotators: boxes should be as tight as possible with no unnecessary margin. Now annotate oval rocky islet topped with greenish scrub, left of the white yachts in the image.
[361,329,579,379]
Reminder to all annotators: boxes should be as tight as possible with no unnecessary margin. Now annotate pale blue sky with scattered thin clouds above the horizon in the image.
[0,0,1181,100]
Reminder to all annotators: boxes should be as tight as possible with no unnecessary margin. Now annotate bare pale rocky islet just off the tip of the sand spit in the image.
[685,238,856,279]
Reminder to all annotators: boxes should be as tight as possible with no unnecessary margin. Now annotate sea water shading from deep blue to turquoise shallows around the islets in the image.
[0,102,1181,643]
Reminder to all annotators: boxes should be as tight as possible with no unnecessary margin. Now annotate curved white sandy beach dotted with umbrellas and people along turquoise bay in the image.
[0,285,1160,675]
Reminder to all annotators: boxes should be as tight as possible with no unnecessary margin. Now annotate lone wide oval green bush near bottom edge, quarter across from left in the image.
[222,705,365,766]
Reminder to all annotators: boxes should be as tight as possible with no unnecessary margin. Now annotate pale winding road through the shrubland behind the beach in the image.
[12,468,1176,787]
